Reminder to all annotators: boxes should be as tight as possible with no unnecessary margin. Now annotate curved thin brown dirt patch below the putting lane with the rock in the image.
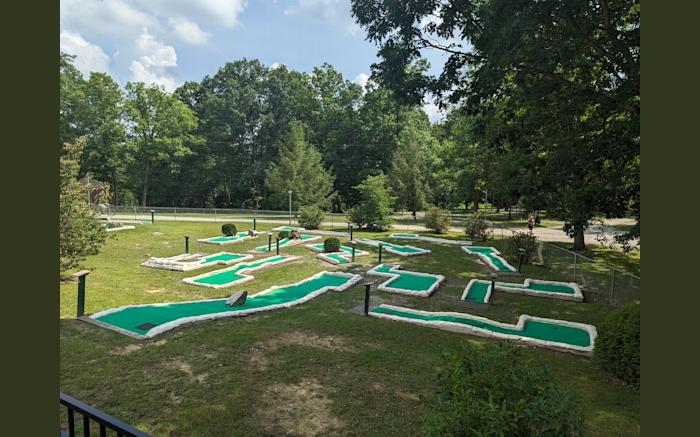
[250,330,355,370]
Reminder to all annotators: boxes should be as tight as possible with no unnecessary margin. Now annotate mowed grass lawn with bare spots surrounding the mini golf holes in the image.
[60,222,640,436]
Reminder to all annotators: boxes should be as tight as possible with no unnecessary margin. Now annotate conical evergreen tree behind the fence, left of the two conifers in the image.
[266,121,333,209]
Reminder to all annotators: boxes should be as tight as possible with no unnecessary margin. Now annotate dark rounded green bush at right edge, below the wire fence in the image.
[593,303,641,388]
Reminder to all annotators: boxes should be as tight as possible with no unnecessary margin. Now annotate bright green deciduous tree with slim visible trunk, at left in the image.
[126,82,198,206]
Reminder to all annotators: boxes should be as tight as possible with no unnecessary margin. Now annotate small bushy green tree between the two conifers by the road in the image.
[347,173,393,230]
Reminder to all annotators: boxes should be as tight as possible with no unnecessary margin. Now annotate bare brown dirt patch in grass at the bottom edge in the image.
[258,378,343,436]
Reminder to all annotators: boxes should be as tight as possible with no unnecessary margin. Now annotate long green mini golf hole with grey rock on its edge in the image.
[90,272,362,339]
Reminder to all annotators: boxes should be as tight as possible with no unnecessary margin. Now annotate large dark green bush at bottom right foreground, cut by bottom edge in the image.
[423,343,584,436]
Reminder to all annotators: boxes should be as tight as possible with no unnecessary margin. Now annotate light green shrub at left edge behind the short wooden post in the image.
[58,140,107,272]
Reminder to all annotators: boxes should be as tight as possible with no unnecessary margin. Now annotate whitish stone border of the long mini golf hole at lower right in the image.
[369,304,598,356]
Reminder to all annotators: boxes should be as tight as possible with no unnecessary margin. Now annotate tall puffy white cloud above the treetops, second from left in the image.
[129,30,178,92]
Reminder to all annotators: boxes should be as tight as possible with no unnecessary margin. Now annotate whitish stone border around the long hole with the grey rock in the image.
[83,271,362,340]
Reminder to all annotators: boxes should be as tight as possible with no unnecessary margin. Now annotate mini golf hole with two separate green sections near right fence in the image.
[462,278,583,303]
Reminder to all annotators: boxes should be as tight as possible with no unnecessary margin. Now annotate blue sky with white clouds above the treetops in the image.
[60,0,445,120]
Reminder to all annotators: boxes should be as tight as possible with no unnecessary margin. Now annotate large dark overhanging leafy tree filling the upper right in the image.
[352,0,641,249]
